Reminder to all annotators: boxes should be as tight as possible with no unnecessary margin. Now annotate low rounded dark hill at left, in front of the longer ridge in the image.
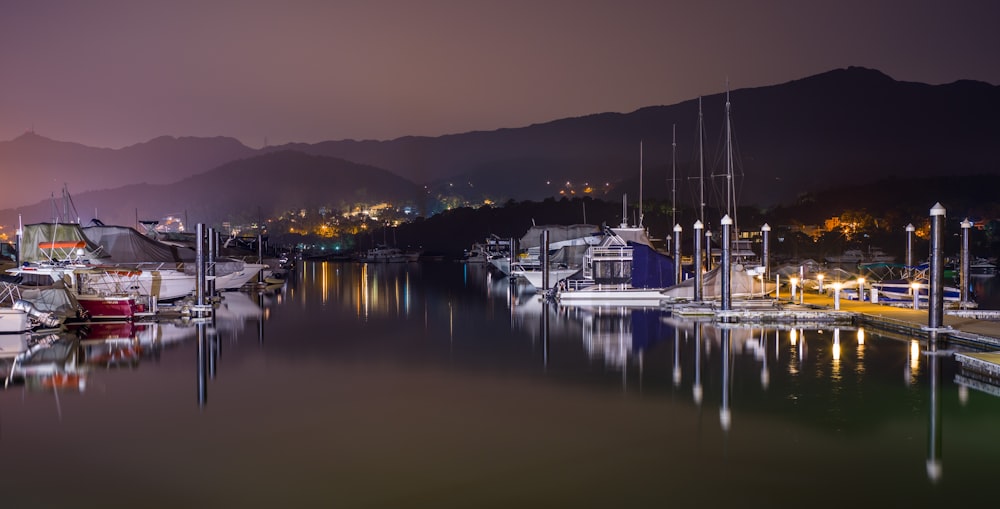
[0,151,423,226]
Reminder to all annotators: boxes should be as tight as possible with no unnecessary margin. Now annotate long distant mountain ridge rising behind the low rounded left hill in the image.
[0,67,1000,218]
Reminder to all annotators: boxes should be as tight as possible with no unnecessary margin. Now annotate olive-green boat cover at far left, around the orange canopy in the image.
[20,223,107,263]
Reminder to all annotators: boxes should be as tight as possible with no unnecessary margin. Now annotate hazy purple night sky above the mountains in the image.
[0,0,1000,148]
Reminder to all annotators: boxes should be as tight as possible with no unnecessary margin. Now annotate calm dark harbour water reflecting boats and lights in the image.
[0,263,1000,507]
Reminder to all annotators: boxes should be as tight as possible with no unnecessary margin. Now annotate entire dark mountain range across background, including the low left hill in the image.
[0,67,1000,225]
